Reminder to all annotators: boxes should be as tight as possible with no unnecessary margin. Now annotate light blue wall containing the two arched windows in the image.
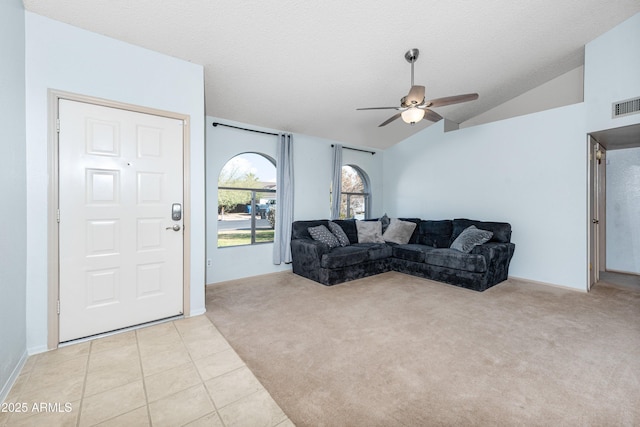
[206,117,383,283]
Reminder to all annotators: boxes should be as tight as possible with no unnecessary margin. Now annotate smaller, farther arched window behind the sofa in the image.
[340,165,371,219]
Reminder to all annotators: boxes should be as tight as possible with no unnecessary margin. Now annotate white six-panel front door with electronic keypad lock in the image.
[59,99,183,342]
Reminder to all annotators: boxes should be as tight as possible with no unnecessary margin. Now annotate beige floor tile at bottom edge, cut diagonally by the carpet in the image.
[218,390,287,427]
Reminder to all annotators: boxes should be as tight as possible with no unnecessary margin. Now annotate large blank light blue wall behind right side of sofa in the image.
[384,104,588,290]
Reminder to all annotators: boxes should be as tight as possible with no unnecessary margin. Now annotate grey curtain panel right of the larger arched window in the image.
[273,134,293,264]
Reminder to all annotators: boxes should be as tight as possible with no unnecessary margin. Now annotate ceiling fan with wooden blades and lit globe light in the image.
[356,49,478,127]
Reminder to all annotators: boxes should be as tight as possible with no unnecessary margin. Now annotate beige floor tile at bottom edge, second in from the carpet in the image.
[149,384,215,427]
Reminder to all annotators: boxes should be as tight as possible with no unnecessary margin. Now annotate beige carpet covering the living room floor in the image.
[207,272,640,426]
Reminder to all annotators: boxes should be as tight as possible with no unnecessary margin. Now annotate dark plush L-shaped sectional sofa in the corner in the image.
[291,218,515,291]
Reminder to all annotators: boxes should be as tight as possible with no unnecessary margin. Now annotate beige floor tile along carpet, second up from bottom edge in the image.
[205,366,263,409]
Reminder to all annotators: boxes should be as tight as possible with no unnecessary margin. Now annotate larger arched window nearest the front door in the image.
[218,153,276,247]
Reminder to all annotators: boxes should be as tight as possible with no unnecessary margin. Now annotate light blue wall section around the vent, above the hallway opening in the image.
[584,13,640,132]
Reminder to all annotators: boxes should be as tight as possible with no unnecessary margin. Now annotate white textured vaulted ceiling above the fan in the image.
[24,0,640,148]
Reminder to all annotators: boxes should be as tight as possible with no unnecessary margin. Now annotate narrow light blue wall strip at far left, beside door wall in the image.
[0,0,27,402]
